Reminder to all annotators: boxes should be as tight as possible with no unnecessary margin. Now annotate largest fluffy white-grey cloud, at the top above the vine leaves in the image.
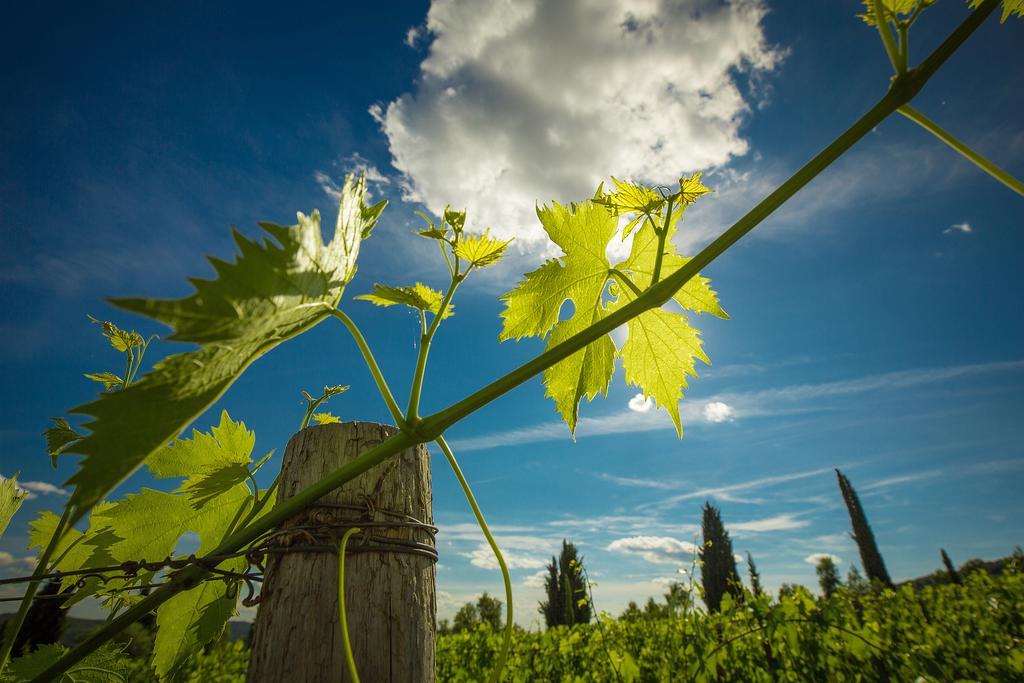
[380,0,780,251]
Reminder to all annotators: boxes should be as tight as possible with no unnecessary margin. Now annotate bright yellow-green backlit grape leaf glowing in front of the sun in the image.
[501,180,716,434]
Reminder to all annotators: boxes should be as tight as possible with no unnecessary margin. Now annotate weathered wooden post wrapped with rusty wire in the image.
[248,422,436,683]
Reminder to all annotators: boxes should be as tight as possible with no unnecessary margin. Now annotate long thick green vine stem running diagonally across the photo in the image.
[34,0,999,683]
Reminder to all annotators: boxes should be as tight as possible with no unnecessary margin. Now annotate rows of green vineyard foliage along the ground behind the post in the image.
[61,565,1024,683]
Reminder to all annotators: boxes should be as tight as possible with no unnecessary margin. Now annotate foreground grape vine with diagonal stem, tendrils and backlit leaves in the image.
[0,0,1024,681]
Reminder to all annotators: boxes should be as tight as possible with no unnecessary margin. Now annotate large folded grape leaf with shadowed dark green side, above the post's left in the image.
[60,176,386,523]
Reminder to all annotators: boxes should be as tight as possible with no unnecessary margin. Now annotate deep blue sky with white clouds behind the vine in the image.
[0,0,1024,626]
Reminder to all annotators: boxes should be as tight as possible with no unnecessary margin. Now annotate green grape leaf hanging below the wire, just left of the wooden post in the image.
[152,557,246,681]
